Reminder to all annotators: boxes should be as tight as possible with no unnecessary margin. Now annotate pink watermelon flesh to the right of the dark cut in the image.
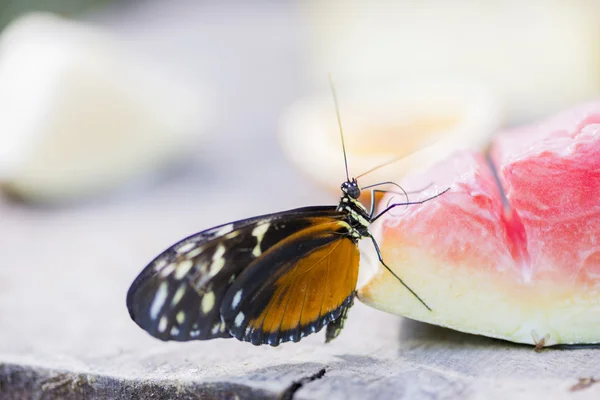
[492,103,600,286]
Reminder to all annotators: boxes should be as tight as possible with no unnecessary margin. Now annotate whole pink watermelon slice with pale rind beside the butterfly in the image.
[359,102,600,345]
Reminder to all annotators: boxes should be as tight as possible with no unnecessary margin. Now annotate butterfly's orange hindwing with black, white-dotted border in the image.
[221,220,360,346]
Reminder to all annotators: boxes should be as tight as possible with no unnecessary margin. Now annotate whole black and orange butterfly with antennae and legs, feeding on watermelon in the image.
[127,82,445,346]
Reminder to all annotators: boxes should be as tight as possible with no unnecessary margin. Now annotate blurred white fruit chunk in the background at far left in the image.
[0,13,208,201]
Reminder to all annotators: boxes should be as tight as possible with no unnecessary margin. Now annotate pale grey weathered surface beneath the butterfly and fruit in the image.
[0,0,600,400]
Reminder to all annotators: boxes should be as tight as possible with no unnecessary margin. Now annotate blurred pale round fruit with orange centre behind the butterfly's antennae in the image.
[280,79,503,193]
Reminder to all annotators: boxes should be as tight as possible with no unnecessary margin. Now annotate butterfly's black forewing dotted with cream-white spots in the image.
[127,207,352,341]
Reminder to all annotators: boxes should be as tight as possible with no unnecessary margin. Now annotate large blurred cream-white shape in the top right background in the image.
[305,0,600,122]
